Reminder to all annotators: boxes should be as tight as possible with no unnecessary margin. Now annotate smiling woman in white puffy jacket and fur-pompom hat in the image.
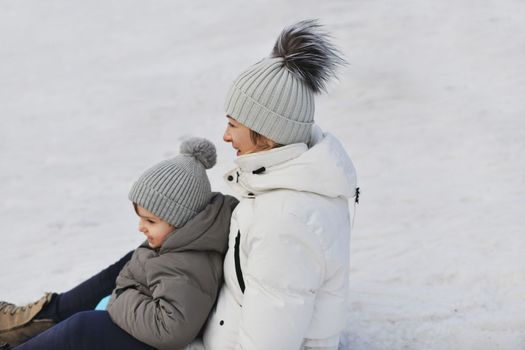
[0,21,356,350]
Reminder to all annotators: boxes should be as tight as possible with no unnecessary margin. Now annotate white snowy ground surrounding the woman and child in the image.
[0,0,525,350]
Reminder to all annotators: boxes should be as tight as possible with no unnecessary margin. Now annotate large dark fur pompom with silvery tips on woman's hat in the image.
[271,20,346,93]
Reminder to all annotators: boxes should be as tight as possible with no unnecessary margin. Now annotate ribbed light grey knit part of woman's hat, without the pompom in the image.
[225,58,315,145]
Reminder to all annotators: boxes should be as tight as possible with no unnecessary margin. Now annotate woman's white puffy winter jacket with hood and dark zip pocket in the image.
[203,128,356,350]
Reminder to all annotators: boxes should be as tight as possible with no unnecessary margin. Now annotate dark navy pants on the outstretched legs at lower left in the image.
[14,252,154,350]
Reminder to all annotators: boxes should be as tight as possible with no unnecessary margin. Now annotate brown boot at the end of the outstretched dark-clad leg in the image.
[0,293,55,347]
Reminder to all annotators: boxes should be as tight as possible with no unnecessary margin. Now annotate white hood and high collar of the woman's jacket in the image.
[225,126,357,198]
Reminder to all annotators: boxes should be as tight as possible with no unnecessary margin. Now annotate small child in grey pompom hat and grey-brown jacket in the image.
[0,138,237,350]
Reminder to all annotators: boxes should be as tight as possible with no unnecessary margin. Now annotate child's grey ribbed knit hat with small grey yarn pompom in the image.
[128,137,217,227]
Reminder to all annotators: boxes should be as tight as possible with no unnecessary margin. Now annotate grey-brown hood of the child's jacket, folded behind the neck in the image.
[141,193,238,254]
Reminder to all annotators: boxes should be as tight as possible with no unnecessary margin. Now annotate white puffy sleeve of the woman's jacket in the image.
[238,212,324,350]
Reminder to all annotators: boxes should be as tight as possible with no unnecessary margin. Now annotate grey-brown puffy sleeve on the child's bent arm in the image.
[108,253,219,350]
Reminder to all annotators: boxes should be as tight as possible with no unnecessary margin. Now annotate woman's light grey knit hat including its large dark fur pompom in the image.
[225,20,345,145]
